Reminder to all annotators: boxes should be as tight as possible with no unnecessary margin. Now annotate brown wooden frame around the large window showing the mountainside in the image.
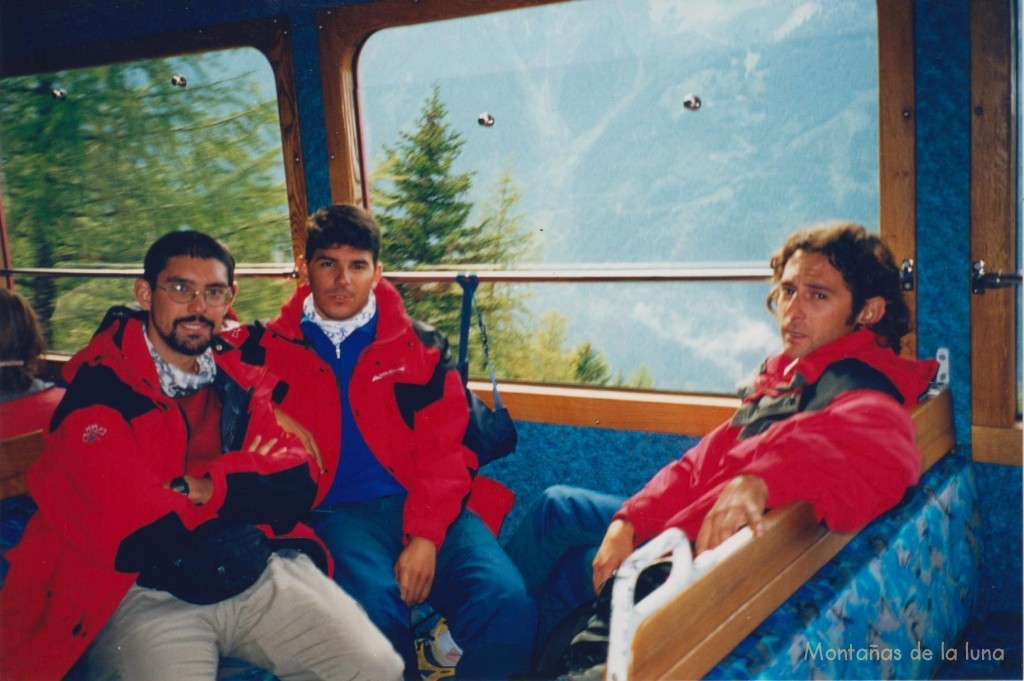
[316,0,916,435]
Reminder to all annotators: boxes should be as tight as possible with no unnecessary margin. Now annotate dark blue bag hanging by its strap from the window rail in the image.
[457,274,519,467]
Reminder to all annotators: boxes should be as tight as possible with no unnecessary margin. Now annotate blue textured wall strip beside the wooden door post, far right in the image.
[914,0,1022,639]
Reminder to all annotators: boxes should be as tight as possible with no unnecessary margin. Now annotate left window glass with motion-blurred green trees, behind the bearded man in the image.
[0,48,292,349]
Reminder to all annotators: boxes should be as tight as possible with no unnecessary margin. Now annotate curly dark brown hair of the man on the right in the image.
[767,221,910,353]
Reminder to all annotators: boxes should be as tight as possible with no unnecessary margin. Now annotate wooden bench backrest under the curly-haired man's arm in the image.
[630,390,956,679]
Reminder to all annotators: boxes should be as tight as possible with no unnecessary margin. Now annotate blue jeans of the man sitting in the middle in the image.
[308,497,537,679]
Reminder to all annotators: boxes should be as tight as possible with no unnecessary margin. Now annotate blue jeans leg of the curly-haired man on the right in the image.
[505,484,626,645]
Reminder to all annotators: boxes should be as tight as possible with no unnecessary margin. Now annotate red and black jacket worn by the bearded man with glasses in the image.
[0,307,328,681]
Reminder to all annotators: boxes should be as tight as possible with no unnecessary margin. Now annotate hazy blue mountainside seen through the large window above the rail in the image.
[359,0,878,263]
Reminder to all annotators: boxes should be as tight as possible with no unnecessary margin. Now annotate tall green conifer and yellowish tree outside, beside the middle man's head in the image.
[373,87,530,376]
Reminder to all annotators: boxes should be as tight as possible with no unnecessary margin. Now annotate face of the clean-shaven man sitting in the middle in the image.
[303,246,383,322]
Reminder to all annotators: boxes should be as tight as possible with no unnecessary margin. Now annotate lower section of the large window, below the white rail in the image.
[398,282,780,392]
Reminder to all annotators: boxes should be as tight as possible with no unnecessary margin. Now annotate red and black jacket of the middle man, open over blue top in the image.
[226,280,514,547]
